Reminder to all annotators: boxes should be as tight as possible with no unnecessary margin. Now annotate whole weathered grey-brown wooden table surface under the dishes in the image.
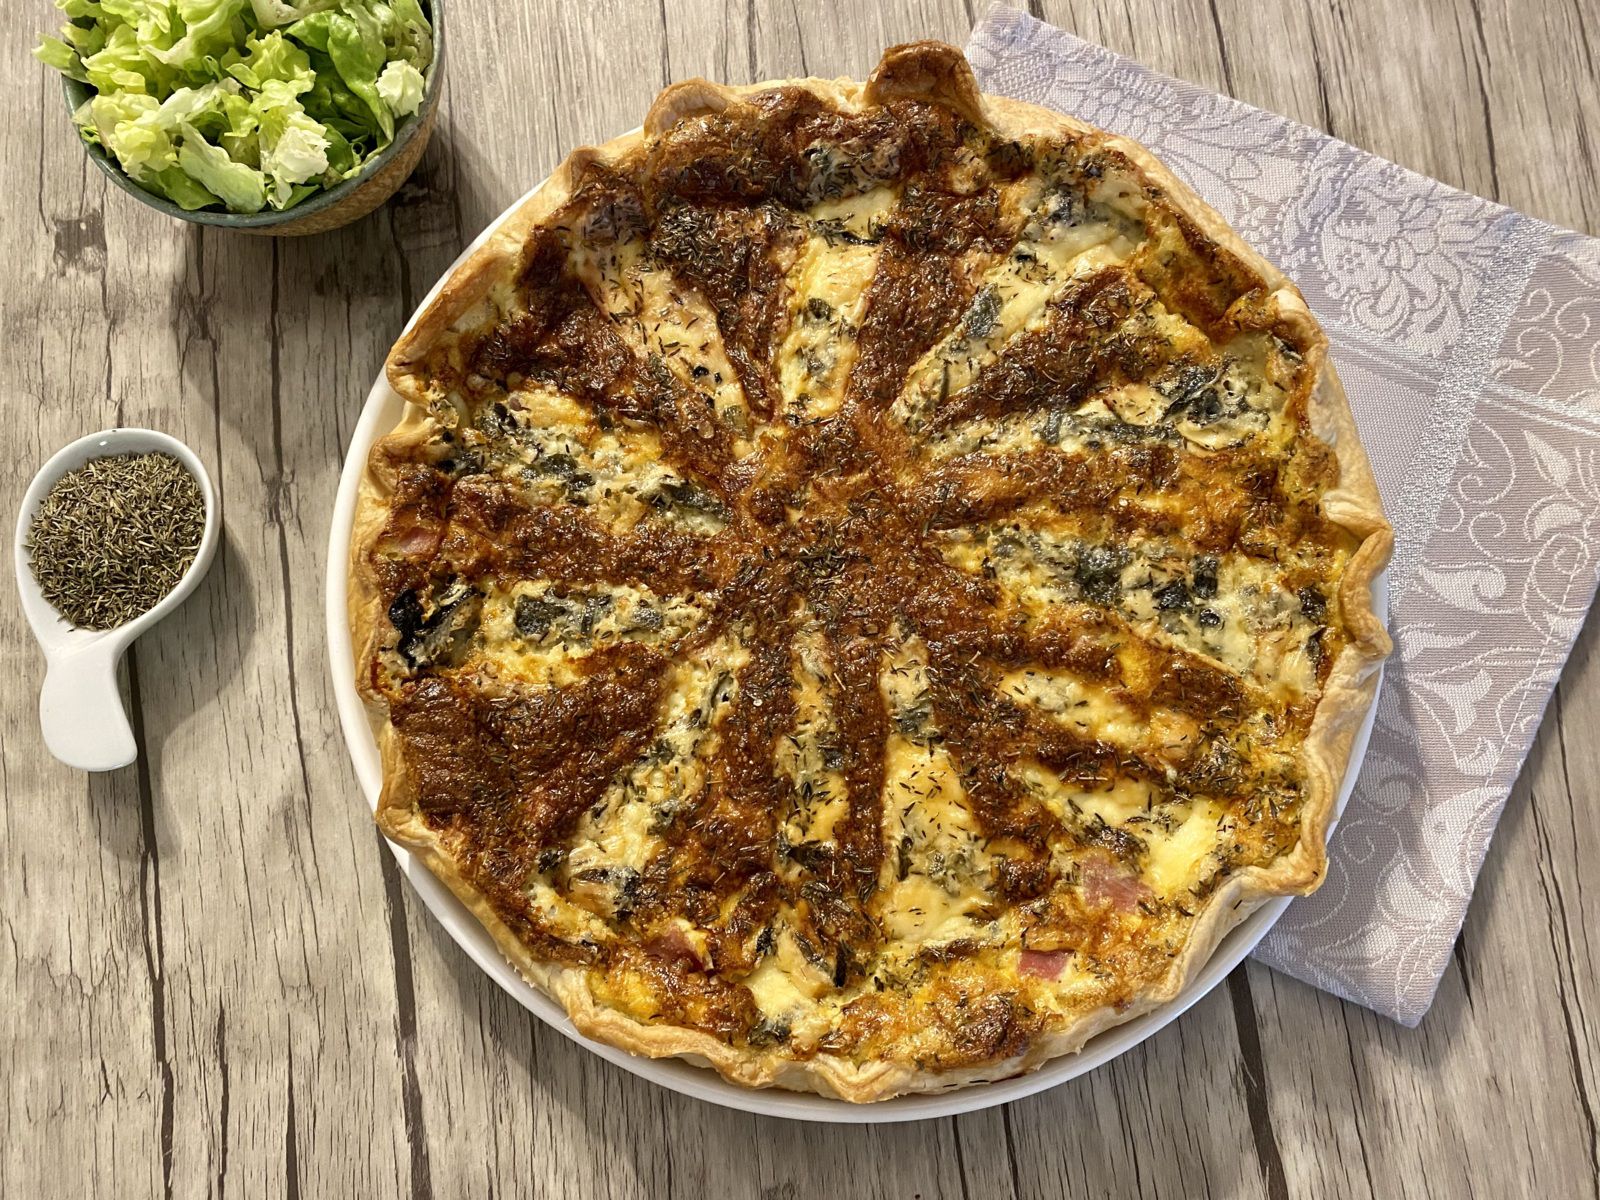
[0,0,1600,1200]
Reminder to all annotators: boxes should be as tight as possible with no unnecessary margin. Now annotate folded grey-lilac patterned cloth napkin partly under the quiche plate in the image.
[966,6,1600,1026]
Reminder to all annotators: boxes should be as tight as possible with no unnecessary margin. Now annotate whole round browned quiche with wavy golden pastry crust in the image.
[350,43,1392,1101]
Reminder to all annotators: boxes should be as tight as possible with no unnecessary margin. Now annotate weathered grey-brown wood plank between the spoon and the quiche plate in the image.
[90,205,416,1195]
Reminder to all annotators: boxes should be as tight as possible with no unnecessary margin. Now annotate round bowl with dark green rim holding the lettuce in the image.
[62,0,445,237]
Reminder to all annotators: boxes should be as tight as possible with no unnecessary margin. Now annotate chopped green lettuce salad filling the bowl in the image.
[34,0,434,213]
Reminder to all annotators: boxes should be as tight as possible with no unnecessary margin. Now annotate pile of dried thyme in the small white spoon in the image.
[27,453,205,629]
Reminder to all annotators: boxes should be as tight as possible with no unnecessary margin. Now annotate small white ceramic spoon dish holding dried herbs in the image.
[14,429,222,771]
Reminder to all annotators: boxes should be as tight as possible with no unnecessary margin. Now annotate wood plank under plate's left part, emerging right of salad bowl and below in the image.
[371,6,707,1197]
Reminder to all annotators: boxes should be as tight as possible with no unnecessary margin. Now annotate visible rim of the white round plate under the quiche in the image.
[326,173,1389,1125]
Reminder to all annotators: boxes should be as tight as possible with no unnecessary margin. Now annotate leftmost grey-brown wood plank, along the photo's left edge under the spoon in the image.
[0,21,171,1195]
